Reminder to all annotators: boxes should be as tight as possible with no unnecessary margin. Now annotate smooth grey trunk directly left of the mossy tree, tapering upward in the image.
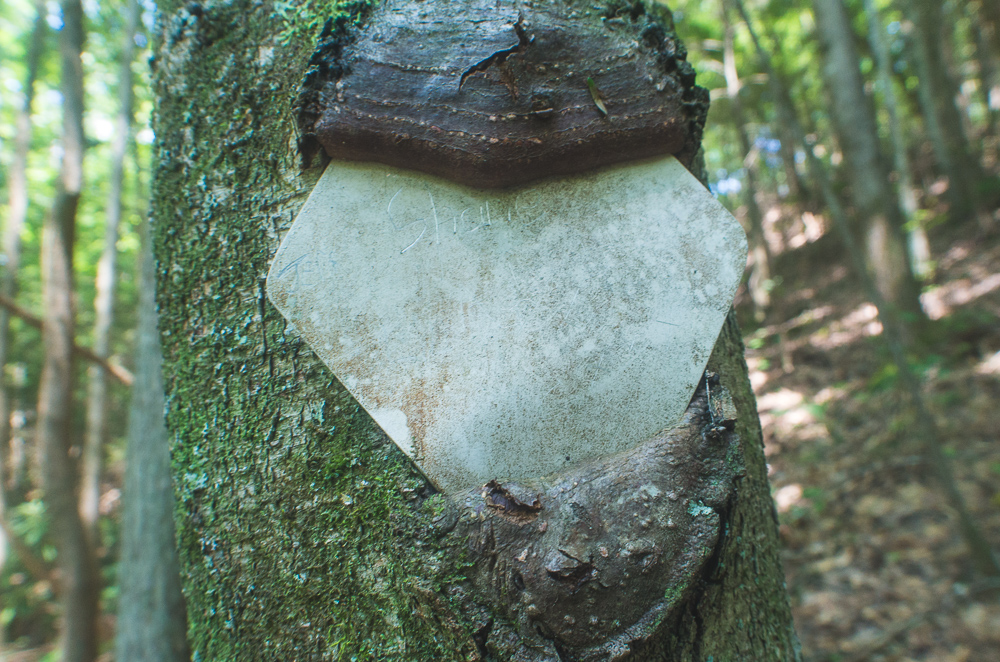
[115,210,190,662]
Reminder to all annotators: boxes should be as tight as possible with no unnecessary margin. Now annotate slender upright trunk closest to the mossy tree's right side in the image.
[722,2,771,322]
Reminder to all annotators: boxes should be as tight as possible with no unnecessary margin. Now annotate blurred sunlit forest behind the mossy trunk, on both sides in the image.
[0,0,1000,662]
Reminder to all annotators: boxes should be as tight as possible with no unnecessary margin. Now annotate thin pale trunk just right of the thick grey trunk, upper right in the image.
[864,0,931,277]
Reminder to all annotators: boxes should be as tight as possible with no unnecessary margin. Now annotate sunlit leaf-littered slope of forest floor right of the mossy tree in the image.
[737,204,1000,662]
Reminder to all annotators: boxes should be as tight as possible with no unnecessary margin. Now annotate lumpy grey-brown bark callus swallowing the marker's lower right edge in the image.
[448,380,745,662]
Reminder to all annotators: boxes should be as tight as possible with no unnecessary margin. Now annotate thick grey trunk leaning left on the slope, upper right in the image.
[813,0,922,315]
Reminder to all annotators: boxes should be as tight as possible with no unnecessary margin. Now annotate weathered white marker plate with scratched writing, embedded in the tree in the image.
[267,156,747,493]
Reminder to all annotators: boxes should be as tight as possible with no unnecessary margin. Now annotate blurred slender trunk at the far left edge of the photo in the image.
[0,0,47,528]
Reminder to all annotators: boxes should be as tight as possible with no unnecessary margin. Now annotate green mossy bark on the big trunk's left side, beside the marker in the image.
[154,2,480,660]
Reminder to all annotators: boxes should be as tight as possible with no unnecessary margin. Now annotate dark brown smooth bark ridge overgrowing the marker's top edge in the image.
[299,0,708,188]
